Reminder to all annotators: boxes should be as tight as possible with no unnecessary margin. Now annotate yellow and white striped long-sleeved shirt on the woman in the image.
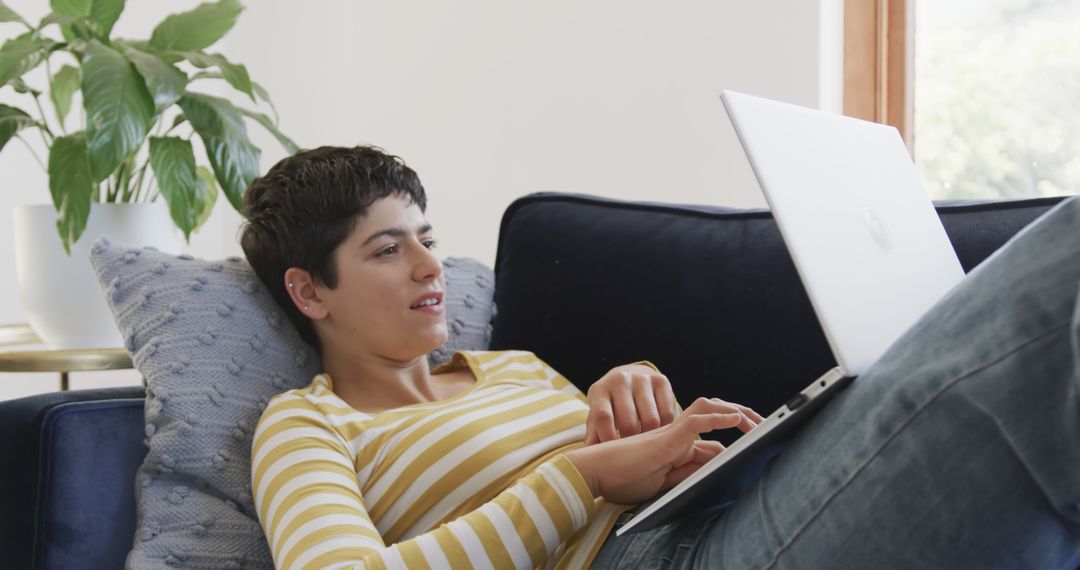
[252,351,630,569]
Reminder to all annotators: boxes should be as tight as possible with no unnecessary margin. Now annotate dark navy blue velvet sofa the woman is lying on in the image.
[0,193,1059,569]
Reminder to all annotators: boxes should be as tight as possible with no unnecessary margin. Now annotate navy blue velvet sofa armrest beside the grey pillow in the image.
[0,386,146,568]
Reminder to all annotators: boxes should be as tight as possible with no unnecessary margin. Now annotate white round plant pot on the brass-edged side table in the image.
[14,201,183,349]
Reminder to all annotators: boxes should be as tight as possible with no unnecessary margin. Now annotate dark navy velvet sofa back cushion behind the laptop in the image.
[491,192,1059,440]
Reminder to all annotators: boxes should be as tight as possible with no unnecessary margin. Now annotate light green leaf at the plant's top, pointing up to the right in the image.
[150,0,244,52]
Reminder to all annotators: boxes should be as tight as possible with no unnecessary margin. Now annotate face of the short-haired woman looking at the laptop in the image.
[316,194,447,362]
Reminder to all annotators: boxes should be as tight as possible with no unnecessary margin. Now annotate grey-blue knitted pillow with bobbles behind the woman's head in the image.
[91,236,495,569]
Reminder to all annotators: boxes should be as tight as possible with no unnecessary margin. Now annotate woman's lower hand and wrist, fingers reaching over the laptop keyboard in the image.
[566,398,760,504]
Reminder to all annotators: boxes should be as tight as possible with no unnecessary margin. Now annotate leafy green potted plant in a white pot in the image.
[0,0,297,348]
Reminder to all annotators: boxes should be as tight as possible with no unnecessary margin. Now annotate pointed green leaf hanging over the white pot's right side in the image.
[150,137,203,240]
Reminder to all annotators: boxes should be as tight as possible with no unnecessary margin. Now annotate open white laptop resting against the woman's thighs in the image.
[618,91,963,534]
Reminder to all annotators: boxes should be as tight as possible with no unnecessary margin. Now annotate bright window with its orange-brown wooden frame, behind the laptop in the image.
[845,0,1080,199]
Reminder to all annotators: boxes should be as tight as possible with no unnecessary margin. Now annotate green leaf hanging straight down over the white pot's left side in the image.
[49,133,95,255]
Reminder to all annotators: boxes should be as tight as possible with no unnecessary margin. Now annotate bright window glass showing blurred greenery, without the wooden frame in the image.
[915,0,1080,198]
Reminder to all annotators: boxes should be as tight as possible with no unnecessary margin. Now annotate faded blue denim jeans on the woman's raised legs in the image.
[593,198,1080,569]
